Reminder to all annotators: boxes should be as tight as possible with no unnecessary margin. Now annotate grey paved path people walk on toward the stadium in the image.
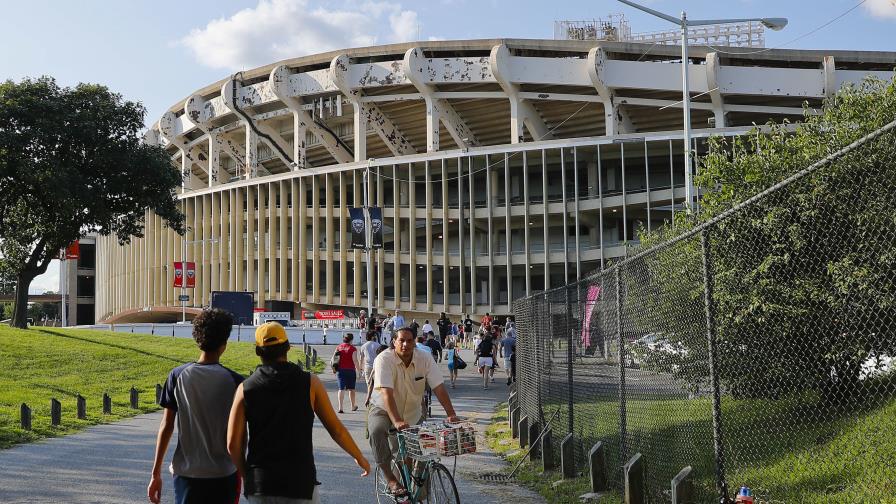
[0,346,544,504]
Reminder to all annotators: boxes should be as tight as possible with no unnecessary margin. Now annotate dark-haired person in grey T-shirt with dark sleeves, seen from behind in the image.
[146,308,243,504]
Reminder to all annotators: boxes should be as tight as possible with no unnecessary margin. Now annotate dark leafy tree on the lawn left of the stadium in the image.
[0,77,184,328]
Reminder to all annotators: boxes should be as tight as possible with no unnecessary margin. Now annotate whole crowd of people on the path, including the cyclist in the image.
[147,309,516,504]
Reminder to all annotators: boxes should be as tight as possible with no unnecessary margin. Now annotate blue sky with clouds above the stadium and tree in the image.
[0,0,896,292]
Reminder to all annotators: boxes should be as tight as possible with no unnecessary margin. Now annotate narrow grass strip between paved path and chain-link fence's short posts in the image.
[485,403,622,504]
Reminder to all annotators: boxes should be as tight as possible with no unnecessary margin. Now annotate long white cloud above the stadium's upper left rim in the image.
[178,0,419,70]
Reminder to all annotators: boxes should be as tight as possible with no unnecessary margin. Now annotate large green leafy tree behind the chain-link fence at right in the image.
[643,79,896,401]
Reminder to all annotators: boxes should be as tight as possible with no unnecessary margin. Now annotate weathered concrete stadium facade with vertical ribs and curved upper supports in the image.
[96,39,896,320]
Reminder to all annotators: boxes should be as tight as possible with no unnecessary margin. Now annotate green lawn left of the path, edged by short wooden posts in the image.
[0,327,324,448]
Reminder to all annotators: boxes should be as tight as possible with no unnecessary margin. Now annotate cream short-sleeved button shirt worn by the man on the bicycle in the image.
[370,348,443,425]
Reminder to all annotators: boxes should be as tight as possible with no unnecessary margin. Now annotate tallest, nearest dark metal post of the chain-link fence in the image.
[700,229,729,502]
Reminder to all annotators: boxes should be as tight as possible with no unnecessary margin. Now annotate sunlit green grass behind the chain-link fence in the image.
[545,388,896,504]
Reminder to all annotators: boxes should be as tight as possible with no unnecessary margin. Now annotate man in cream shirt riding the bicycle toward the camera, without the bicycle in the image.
[367,327,459,496]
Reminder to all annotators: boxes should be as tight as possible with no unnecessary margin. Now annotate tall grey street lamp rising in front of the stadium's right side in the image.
[619,0,787,211]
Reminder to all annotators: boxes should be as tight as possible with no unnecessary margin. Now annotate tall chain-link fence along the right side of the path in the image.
[513,119,896,503]
